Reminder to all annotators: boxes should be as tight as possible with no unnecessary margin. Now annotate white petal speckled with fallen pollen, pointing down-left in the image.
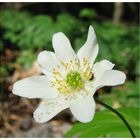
[33,97,69,123]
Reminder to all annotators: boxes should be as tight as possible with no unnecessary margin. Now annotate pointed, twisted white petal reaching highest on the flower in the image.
[77,26,99,68]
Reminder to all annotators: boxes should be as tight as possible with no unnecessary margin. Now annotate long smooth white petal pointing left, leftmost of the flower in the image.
[12,76,59,99]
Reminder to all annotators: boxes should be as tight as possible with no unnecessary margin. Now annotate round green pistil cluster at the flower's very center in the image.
[65,71,82,88]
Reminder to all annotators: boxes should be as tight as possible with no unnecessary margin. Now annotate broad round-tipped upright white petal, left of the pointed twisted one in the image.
[52,32,78,66]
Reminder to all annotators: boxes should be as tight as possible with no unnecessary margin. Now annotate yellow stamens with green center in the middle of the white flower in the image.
[51,58,93,97]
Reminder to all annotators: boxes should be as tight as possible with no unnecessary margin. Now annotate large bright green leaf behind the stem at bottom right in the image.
[65,108,139,137]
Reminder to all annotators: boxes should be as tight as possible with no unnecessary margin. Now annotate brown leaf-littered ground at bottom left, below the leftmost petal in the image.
[0,92,72,137]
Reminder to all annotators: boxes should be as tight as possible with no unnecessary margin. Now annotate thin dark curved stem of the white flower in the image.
[95,99,136,138]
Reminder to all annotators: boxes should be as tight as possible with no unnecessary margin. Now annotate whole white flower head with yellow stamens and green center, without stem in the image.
[13,26,126,123]
